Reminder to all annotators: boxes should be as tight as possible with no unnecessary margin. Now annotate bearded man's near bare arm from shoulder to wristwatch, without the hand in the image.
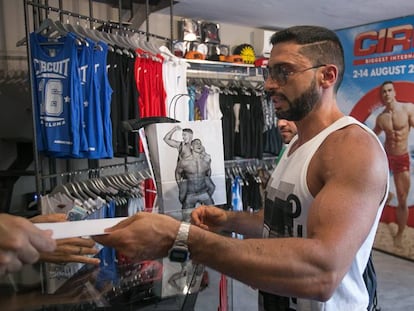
[190,126,388,300]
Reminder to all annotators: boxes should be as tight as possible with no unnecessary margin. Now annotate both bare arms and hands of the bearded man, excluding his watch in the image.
[96,125,388,301]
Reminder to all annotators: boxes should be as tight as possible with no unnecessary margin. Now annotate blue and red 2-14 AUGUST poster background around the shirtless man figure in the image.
[336,16,414,260]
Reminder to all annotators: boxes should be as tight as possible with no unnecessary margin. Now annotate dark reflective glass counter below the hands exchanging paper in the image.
[0,213,204,311]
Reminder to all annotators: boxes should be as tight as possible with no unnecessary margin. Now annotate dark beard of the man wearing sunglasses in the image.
[276,79,320,121]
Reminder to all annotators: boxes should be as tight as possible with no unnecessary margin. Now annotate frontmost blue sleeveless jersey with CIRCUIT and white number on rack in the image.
[30,32,82,157]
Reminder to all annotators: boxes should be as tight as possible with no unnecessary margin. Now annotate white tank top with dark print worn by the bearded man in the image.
[263,116,385,311]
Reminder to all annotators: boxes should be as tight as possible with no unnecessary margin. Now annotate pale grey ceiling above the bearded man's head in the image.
[158,0,414,30]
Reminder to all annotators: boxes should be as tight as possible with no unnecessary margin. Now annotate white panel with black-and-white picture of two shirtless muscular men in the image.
[145,120,227,216]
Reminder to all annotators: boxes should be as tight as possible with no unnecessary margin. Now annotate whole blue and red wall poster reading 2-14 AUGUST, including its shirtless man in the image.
[337,16,414,260]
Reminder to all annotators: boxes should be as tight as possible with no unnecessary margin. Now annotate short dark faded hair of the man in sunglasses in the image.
[270,26,345,92]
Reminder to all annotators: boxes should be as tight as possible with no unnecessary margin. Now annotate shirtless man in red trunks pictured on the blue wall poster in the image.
[374,81,414,247]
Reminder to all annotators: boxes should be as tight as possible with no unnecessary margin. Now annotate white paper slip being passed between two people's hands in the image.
[34,217,127,239]
